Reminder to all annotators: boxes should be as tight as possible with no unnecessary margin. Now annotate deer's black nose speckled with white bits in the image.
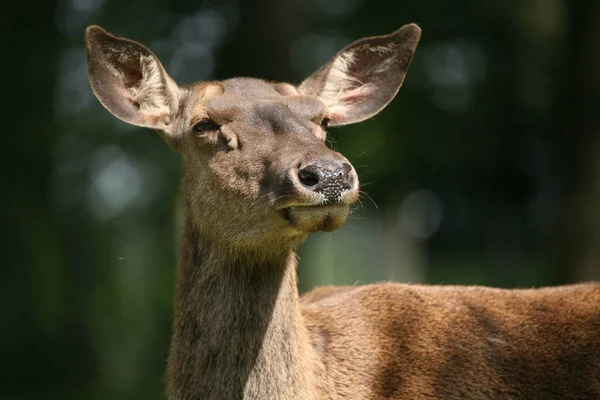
[298,162,352,201]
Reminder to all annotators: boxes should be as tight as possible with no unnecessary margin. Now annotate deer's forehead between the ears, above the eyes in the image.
[192,78,327,120]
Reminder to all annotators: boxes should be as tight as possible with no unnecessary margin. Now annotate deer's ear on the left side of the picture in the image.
[85,26,181,136]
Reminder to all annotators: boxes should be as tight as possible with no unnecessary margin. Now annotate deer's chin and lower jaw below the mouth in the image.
[282,204,350,233]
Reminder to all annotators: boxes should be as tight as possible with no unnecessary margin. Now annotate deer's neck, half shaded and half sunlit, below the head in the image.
[167,222,311,400]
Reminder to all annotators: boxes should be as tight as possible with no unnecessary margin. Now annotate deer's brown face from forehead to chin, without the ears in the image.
[181,78,358,233]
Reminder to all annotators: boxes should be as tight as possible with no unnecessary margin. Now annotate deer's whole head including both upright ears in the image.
[86,25,420,246]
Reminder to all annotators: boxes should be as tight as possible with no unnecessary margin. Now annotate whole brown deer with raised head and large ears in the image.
[85,24,600,400]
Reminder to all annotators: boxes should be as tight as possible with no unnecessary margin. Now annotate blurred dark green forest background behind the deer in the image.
[0,0,600,400]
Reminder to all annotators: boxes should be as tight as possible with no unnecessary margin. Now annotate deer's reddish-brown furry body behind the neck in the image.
[302,283,600,400]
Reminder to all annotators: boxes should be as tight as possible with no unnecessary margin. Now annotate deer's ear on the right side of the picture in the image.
[298,24,421,125]
